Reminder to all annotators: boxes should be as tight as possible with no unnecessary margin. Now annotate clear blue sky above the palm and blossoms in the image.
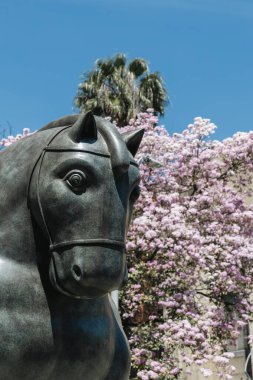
[0,0,253,139]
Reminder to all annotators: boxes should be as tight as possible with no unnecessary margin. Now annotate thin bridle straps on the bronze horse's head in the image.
[27,125,132,252]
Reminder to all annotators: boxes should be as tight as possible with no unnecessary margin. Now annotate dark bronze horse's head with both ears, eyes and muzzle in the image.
[28,113,143,299]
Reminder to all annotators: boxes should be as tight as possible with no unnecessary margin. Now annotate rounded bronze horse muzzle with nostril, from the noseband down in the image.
[49,239,126,299]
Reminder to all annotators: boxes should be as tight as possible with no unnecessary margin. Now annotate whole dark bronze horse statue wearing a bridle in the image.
[0,113,143,380]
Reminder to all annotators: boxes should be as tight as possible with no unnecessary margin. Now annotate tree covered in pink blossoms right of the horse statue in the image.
[120,112,253,380]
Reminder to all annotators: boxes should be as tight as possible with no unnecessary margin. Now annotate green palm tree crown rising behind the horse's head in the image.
[75,53,168,126]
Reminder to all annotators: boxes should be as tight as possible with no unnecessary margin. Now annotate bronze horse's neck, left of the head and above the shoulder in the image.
[0,131,52,264]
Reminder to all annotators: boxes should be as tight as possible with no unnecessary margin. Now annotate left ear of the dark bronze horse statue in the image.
[69,112,97,143]
